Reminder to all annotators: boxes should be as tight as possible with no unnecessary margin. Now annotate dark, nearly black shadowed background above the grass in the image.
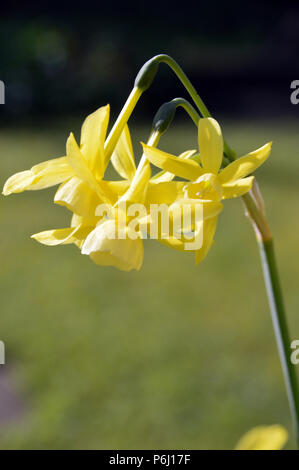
[0,1,299,122]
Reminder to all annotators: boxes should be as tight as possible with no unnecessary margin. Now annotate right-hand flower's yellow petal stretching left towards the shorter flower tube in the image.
[142,143,204,181]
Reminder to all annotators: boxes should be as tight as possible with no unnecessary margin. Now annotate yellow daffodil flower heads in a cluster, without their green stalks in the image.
[3,105,271,271]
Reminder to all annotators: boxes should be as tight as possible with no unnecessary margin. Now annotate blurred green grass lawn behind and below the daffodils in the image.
[0,117,299,449]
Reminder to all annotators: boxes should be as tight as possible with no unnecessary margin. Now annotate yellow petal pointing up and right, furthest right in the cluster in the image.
[219,142,272,184]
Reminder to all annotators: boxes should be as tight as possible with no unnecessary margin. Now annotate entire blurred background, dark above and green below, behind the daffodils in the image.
[0,1,299,449]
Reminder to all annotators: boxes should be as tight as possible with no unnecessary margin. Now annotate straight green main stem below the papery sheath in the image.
[258,239,299,447]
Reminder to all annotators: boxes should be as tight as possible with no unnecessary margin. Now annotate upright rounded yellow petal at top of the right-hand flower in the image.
[198,118,223,174]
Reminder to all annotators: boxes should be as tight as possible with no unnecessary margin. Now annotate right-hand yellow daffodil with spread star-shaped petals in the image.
[142,118,271,263]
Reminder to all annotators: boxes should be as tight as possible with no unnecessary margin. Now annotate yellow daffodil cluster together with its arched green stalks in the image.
[3,54,271,271]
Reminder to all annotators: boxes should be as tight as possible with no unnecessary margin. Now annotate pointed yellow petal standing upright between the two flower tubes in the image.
[111,124,136,181]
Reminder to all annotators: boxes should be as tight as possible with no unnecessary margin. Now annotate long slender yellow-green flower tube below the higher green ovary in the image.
[105,87,142,161]
